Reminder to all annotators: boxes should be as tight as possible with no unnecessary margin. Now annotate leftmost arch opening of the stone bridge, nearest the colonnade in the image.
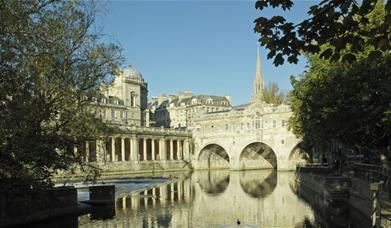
[198,144,229,169]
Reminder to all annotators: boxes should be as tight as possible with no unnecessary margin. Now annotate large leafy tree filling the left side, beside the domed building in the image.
[0,0,122,188]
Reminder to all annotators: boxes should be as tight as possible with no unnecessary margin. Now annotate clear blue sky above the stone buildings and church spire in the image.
[98,0,317,105]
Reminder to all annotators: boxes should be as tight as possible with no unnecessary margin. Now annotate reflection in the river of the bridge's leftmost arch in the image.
[198,170,230,195]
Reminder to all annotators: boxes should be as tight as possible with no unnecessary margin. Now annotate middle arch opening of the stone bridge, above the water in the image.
[239,142,277,170]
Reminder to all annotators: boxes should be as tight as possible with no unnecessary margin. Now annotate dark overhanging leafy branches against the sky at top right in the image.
[254,0,391,66]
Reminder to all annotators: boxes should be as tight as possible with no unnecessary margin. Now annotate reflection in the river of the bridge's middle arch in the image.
[240,169,277,198]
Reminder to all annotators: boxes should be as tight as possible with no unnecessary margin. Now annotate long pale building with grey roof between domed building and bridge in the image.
[148,92,232,129]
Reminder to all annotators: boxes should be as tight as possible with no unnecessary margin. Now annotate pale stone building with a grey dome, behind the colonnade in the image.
[91,65,149,126]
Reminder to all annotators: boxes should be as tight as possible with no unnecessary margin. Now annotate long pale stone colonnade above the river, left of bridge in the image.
[84,135,190,163]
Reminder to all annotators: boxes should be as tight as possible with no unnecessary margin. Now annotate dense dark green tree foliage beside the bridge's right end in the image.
[290,54,391,153]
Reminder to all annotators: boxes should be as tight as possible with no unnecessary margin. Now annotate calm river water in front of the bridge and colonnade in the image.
[26,170,368,228]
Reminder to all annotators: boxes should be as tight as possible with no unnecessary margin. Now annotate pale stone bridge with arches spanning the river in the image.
[192,107,309,170]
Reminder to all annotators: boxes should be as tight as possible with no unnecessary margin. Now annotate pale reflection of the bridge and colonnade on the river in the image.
[79,170,314,228]
